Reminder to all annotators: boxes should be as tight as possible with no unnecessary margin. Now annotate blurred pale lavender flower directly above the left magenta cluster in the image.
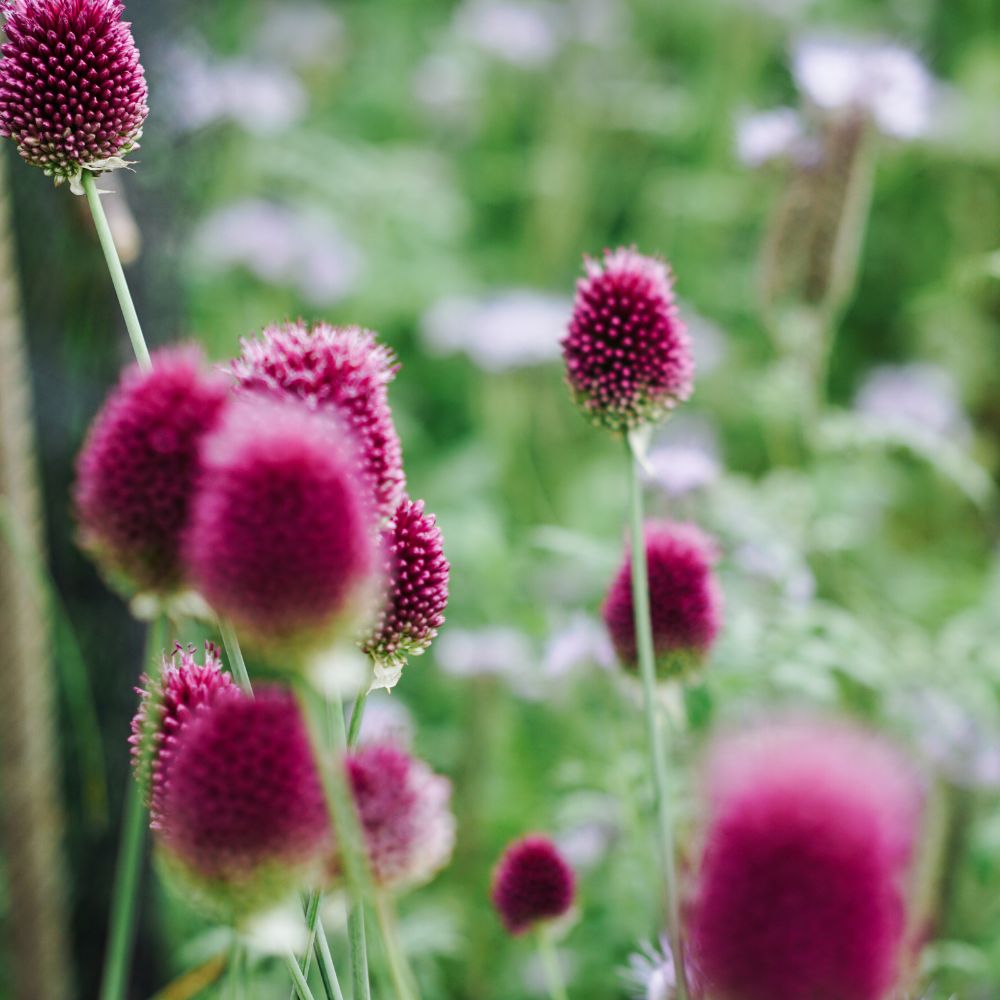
[193,198,363,306]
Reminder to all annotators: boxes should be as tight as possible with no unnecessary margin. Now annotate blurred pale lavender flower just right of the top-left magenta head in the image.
[163,46,308,135]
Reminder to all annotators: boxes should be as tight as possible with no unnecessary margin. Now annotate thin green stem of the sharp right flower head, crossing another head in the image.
[626,435,688,1000]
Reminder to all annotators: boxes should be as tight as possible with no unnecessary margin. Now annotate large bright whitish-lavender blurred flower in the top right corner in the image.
[792,38,935,139]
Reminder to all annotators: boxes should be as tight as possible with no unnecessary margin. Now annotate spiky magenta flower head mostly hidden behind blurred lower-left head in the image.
[129,642,233,829]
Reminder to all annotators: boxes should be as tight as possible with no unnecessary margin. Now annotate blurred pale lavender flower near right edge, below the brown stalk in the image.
[855,362,971,444]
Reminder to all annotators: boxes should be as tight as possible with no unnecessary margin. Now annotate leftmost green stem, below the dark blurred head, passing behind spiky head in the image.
[100,617,166,1000]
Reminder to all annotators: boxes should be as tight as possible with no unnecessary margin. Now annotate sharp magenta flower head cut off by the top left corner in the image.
[0,0,149,183]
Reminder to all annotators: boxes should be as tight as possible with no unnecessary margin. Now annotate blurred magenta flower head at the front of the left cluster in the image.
[185,395,378,652]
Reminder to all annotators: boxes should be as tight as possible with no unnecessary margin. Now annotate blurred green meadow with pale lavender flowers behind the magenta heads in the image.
[0,0,1000,1000]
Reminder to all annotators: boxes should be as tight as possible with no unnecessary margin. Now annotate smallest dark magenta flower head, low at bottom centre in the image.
[492,836,576,934]
